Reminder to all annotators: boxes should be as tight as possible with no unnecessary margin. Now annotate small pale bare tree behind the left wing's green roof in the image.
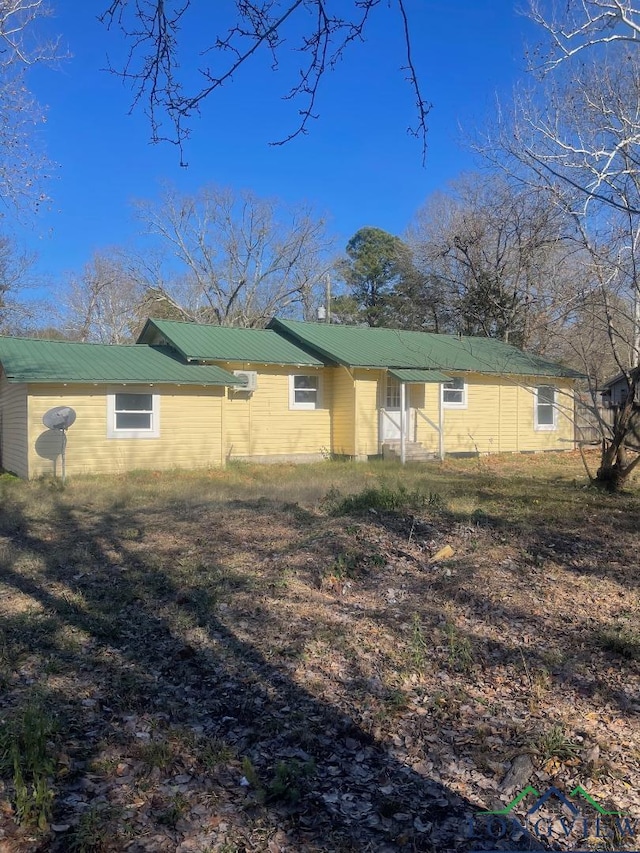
[63,249,144,344]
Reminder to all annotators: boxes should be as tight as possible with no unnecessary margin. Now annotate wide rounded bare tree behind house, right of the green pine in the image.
[408,173,572,351]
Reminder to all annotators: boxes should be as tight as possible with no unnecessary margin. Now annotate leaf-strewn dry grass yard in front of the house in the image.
[0,454,640,853]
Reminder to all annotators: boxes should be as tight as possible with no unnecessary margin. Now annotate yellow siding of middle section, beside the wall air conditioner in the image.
[224,364,332,459]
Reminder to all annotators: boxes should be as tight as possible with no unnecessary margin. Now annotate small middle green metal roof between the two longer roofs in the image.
[138,320,323,366]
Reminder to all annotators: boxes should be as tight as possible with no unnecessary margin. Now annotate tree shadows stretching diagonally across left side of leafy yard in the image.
[0,495,552,853]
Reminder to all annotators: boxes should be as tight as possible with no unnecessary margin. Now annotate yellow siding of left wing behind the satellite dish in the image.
[28,385,224,477]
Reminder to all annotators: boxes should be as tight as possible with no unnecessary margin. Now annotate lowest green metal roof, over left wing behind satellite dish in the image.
[0,337,239,385]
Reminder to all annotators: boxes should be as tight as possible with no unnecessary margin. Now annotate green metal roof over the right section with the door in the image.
[269,318,582,378]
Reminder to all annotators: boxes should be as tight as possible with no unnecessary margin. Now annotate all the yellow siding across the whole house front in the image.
[18,365,573,477]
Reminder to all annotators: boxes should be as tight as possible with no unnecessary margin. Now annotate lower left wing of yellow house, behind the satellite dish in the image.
[0,338,237,478]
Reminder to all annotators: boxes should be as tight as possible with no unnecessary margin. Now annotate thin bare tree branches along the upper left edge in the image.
[0,0,58,208]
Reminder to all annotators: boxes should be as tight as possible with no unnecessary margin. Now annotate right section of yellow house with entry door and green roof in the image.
[270,319,580,459]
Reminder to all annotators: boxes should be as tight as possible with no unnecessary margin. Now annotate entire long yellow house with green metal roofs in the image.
[0,319,578,477]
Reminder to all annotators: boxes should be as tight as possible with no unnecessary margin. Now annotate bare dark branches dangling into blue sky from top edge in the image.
[101,0,430,161]
